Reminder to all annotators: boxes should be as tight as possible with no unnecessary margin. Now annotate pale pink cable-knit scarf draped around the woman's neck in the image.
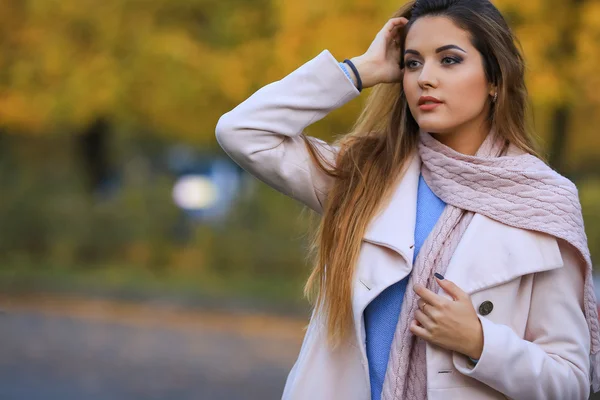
[382,130,600,400]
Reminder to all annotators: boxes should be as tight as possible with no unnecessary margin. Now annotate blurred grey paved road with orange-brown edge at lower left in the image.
[0,298,304,400]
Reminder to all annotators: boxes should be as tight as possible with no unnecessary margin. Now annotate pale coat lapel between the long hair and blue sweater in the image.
[363,151,421,265]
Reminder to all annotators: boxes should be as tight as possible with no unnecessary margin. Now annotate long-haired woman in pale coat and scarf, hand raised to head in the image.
[217,0,600,400]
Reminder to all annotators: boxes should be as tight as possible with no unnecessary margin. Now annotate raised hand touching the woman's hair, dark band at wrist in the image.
[351,17,408,88]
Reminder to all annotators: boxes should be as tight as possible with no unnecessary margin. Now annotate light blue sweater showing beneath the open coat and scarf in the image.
[364,176,446,400]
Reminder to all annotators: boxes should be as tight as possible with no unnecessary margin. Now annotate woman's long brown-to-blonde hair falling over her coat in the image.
[304,0,540,347]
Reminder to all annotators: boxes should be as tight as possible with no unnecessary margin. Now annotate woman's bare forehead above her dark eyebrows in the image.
[405,16,473,52]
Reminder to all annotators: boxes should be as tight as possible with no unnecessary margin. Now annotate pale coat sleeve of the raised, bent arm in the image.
[216,50,359,213]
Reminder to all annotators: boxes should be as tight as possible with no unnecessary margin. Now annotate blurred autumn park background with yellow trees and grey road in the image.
[0,0,600,400]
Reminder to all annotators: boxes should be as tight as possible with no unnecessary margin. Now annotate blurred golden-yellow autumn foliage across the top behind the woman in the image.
[0,0,600,166]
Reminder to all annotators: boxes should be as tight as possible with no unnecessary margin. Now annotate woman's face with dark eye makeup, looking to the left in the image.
[403,16,494,134]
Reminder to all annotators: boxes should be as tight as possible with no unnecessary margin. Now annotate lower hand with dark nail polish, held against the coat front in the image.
[410,278,483,359]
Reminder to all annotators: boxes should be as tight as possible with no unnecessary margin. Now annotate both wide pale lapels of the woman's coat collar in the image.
[358,145,563,295]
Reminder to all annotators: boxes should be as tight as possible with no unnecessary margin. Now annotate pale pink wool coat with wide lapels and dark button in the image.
[216,51,590,400]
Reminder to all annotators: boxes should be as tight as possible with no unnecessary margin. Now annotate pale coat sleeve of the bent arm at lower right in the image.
[453,240,590,400]
